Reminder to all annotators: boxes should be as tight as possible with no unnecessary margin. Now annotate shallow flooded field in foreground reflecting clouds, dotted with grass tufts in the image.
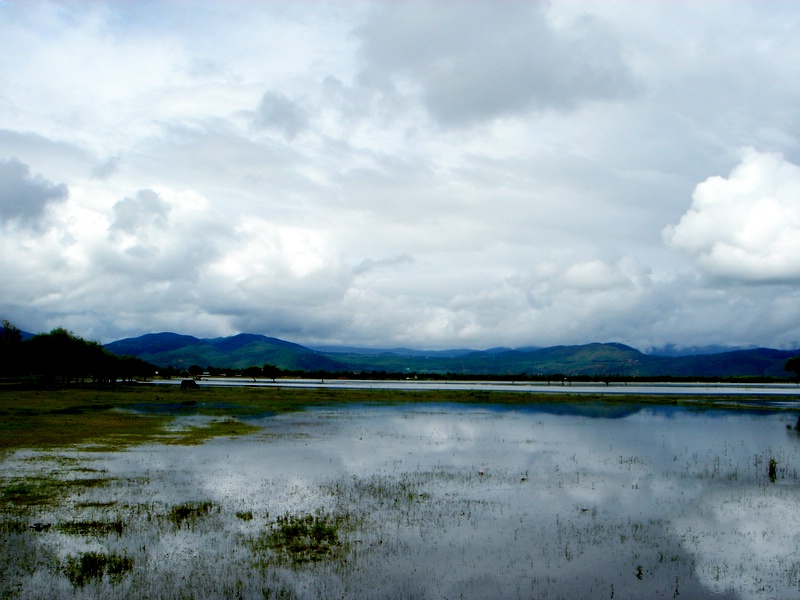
[0,401,800,599]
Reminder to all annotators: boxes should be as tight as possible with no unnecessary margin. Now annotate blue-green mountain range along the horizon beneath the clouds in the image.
[105,333,800,378]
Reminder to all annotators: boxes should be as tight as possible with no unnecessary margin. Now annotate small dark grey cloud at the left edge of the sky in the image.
[0,158,69,226]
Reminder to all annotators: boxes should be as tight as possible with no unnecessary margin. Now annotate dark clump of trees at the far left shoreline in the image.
[0,321,157,384]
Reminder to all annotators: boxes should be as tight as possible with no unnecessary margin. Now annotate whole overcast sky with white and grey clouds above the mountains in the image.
[0,0,800,351]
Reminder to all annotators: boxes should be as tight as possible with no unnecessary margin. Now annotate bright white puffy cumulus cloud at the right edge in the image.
[664,149,800,284]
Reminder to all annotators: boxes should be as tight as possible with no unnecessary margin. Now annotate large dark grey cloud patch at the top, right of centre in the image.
[358,1,637,125]
